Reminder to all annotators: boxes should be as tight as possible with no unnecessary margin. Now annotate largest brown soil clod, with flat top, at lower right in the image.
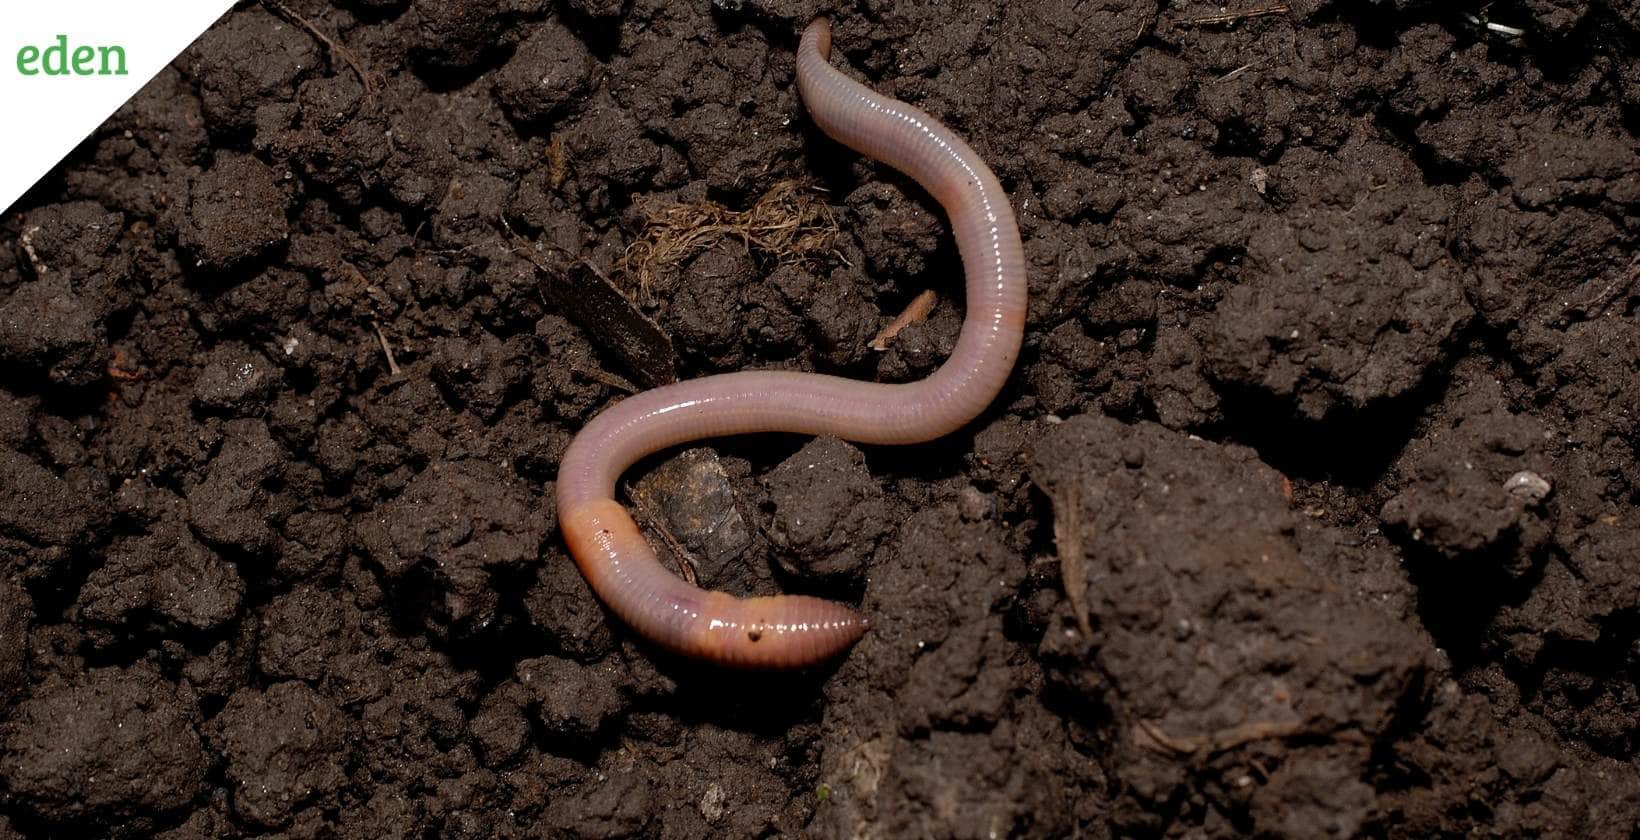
[1032,418,1435,837]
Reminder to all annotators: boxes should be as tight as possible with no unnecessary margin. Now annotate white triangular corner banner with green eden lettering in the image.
[0,0,233,210]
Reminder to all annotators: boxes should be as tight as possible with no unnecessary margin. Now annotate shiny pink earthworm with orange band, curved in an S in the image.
[556,18,1025,668]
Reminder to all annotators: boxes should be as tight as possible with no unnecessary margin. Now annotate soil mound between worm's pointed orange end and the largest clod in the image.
[813,485,1102,837]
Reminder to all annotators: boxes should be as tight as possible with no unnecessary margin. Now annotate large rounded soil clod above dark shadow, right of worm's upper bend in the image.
[1205,146,1469,418]
